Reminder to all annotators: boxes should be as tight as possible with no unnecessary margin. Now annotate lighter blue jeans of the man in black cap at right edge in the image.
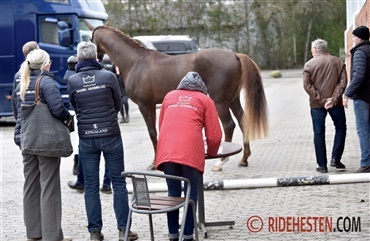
[353,99,370,167]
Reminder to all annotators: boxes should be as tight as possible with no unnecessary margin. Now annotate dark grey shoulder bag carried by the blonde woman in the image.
[21,76,73,157]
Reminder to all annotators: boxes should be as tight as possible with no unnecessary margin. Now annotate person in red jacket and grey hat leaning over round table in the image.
[156,72,222,241]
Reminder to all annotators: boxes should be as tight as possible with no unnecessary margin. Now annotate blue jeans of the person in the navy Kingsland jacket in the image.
[79,135,128,232]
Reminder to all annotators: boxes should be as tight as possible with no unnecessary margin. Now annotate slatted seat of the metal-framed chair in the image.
[132,195,185,210]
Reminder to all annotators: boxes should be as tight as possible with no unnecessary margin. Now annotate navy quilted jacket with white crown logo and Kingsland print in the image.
[68,60,122,138]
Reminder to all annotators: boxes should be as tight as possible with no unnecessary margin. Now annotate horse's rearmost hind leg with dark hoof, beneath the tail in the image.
[230,98,251,167]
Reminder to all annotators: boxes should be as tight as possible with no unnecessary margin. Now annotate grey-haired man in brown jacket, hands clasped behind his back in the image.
[303,39,347,173]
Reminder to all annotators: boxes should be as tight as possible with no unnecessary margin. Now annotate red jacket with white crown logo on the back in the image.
[156,90,222,173]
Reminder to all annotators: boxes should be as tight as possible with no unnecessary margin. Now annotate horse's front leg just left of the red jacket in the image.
[139,104,157,171]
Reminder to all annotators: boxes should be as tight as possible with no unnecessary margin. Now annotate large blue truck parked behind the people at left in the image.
[0,0,108,118]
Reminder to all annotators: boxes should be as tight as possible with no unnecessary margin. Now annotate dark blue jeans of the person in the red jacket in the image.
[162,162,202,239]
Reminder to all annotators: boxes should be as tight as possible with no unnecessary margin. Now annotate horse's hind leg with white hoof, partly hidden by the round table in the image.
[212,103,235,172]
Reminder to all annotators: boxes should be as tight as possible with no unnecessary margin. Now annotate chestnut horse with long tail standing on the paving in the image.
[92,26,268,171]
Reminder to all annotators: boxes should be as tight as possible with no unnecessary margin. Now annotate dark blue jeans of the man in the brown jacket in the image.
[311,106,347,167]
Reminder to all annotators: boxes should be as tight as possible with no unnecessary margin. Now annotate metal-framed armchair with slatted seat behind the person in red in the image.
[121,172,199,241]
